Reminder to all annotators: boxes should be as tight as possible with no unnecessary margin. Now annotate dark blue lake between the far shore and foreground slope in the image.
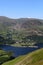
[0,45,39,57]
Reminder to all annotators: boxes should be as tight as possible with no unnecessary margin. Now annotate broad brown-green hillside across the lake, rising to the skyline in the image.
[0,16,43,46]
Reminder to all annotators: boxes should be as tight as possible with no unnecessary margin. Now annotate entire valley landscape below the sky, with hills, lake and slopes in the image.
[0,16,43,65]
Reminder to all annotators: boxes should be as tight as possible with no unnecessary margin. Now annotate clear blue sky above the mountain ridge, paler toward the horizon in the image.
[0,0,43,19]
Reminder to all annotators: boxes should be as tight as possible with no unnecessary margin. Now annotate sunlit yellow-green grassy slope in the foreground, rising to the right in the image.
[2,48,43,65]
